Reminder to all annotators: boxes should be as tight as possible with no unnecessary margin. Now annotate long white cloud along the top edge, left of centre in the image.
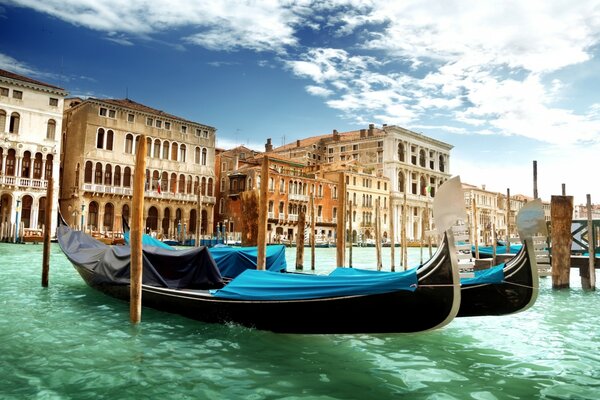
[5,0,299,52]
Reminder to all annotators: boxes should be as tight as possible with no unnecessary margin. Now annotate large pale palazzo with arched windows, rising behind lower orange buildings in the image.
[267,124,453,240]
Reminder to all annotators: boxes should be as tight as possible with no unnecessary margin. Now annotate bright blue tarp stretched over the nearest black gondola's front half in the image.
[211,269,417,300]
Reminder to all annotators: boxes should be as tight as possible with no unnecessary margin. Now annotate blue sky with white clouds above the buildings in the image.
[0,0,600,204]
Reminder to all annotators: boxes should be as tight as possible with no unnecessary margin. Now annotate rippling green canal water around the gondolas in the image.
[0,244,600,400]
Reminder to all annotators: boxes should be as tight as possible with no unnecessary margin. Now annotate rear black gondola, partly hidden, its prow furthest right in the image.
[458,200,546,317]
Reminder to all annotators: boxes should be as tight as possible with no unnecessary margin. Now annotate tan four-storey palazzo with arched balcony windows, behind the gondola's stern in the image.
[60,99,216,240]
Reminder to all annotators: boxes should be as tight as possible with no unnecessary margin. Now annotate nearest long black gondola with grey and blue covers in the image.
[57,177,464,334]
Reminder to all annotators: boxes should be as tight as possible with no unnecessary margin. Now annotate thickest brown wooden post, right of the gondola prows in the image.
[550,196,573,289]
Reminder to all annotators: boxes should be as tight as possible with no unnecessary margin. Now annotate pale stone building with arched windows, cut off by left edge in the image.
[0,70,67,241]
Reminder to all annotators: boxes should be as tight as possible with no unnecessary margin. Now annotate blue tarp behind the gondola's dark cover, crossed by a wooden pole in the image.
[209,244,287,278]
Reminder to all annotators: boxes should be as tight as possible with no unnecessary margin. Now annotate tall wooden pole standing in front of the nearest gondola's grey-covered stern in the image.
[129,135,147,324]
